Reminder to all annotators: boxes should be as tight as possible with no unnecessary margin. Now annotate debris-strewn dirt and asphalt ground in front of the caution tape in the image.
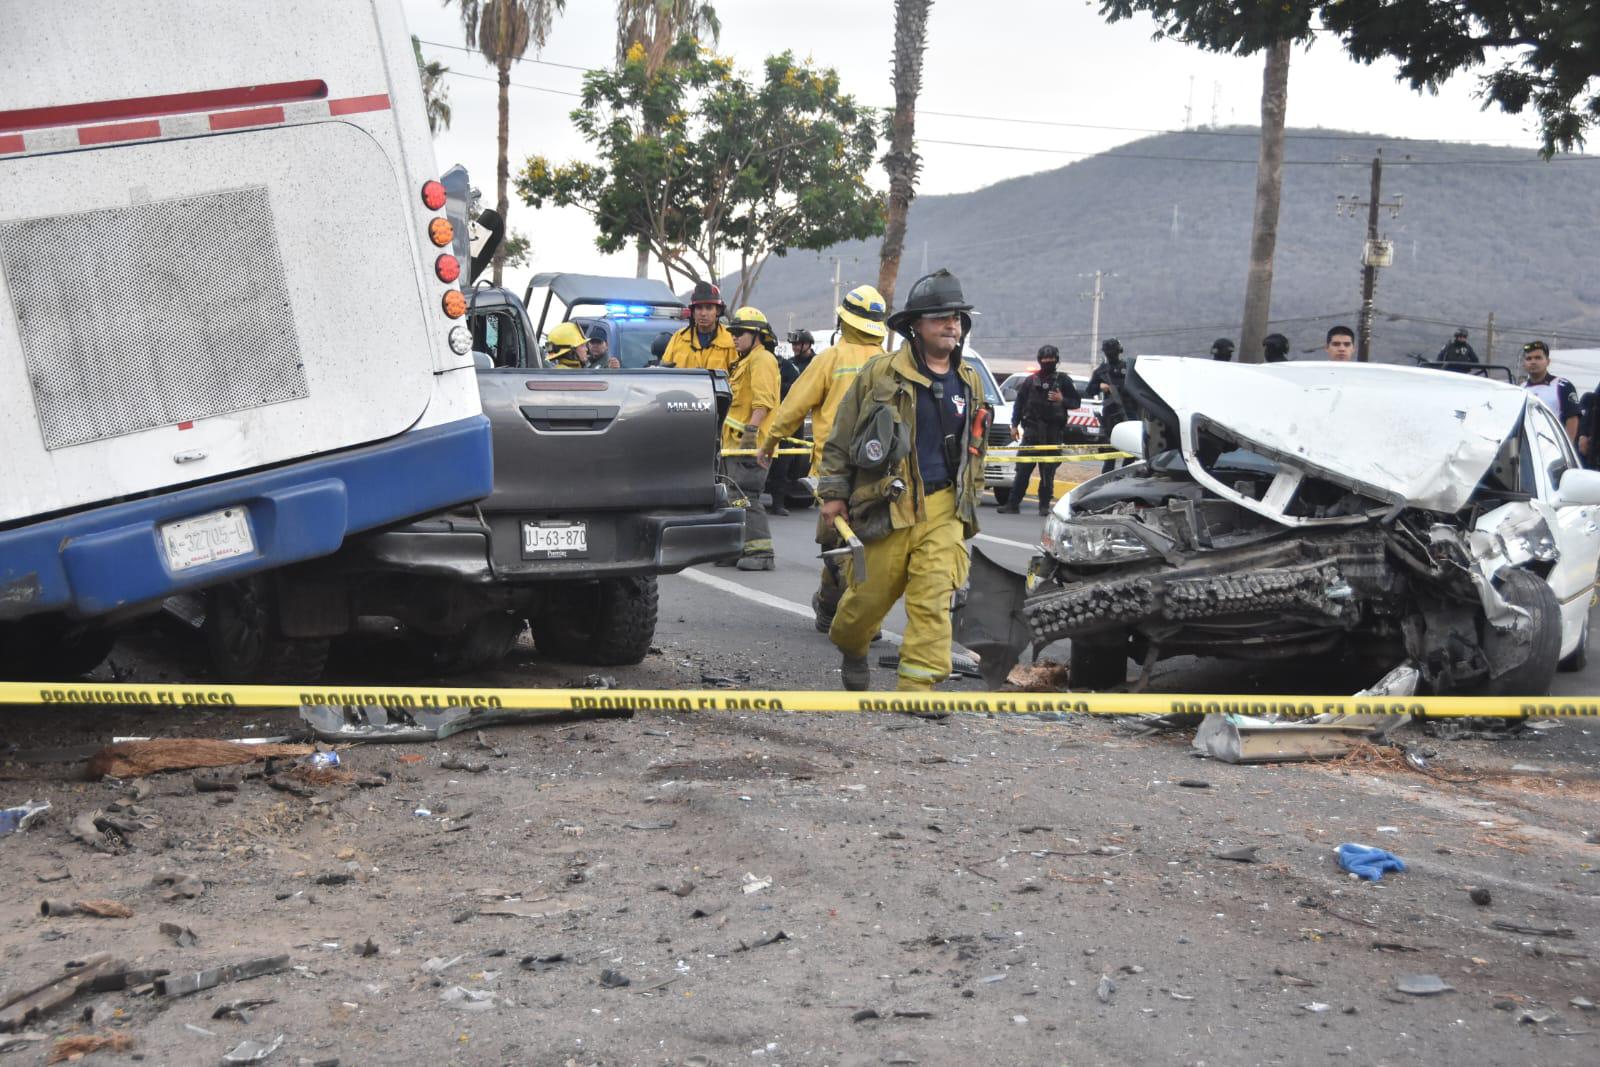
[0,687,1600,1064]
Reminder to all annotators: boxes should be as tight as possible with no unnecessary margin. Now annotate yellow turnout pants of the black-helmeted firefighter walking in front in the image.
[827,490,968,689]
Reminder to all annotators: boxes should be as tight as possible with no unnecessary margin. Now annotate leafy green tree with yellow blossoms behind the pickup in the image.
[517,35,883,306]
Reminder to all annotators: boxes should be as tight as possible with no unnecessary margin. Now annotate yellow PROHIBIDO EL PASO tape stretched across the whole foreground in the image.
[0,681,1580,718]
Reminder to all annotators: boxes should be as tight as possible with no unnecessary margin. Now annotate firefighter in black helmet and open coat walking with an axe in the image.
[818,270,992,689]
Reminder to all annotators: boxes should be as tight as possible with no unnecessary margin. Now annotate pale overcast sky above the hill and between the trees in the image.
[403,0,1538,290]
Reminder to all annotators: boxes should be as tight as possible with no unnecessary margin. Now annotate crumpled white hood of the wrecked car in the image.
[1136,355,1528,525]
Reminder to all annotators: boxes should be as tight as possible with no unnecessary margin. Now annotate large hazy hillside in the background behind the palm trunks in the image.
[754,128,1600,362]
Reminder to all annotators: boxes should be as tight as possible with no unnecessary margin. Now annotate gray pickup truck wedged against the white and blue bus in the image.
[184,175,744,680]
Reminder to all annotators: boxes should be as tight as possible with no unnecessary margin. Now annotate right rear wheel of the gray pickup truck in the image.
[533,574,658,667]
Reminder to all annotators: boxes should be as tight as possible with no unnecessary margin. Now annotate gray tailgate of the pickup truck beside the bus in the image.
[478,368,717,517]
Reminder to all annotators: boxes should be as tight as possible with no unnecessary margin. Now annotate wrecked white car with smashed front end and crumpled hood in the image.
[958,357,1600,696]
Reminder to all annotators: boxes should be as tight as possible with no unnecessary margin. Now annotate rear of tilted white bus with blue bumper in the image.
[0,0,491,670]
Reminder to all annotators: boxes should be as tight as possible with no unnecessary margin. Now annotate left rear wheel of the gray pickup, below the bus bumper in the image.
[200,577,328,681]
